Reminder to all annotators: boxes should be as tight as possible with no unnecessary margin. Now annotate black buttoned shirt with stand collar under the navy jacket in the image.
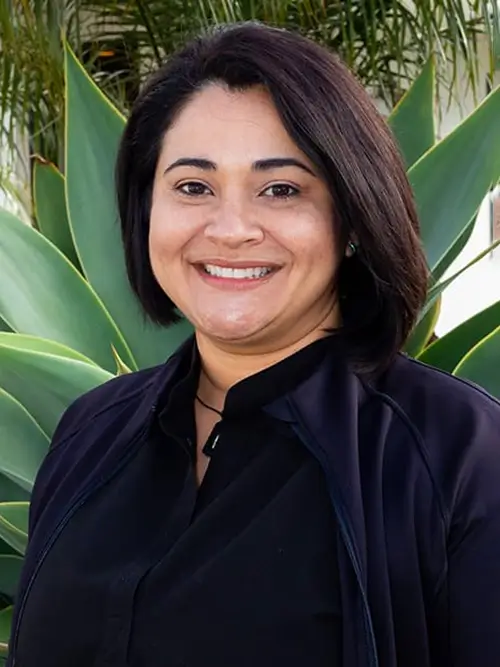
[16,339,341,667]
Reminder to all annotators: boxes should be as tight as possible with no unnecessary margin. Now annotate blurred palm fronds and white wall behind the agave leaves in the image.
[0,0,500,334]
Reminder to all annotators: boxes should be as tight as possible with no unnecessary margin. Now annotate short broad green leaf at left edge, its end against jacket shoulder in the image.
[0,388,49,491]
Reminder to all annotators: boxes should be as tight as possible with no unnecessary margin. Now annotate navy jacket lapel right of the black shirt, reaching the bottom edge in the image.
[266,352,377,667]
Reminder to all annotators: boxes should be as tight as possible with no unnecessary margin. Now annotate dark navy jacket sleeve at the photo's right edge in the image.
[448,406,500,667]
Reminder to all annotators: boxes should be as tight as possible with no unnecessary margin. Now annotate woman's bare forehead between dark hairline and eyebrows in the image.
[158,84,305,163]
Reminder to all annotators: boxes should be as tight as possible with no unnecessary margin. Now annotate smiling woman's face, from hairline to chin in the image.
[149,84,339,347]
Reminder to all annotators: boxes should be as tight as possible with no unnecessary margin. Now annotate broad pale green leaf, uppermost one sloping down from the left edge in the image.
[0,210,135,371]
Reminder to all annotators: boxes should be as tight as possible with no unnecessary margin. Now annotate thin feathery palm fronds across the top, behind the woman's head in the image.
[0,0,500,204]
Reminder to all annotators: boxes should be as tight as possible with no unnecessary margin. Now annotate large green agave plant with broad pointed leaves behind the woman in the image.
[0,47,500,655]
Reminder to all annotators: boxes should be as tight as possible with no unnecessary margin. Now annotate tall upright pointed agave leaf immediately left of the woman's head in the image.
[65,41,191,367]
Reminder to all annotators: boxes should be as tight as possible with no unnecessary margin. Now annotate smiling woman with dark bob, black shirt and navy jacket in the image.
[6,24,500,667]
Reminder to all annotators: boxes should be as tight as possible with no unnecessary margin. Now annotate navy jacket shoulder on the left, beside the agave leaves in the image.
[29,354,186,535]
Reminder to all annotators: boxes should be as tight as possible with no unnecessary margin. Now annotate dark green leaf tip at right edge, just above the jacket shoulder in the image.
[453,326,500,399]
